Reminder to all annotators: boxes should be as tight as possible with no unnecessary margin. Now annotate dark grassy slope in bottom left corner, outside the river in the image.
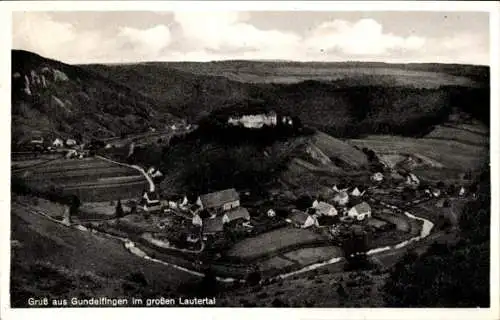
[11,200,197,307]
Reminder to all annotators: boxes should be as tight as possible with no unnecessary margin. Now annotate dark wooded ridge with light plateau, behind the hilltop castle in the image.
[82,61,489,137]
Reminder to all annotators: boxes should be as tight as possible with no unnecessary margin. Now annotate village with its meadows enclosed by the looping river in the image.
[65,154,474,274]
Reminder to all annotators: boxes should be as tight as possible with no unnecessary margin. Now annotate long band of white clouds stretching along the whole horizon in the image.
[13,11,489,64]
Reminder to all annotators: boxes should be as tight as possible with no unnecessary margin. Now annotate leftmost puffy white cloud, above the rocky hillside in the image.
[13,12,171,63]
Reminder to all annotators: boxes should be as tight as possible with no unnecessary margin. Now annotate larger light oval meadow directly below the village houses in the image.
[227,227,325,259]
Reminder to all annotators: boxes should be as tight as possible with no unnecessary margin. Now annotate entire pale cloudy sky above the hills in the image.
[12,11,490,65]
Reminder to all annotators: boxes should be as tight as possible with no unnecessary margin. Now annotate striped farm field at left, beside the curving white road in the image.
[13,158,148,202]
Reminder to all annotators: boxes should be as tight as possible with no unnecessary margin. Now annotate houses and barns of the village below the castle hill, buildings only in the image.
[132,168,472,243]
